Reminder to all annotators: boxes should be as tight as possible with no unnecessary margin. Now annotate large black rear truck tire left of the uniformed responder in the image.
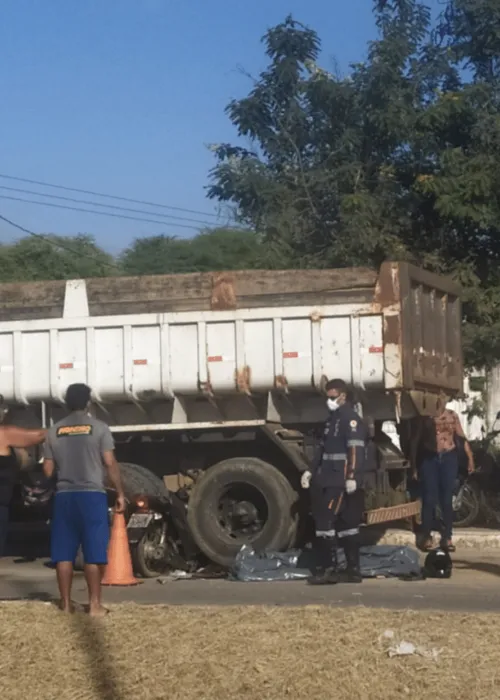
[187,457,298,567]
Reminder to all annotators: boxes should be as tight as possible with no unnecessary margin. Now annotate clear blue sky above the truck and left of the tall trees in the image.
[0,0,434,252]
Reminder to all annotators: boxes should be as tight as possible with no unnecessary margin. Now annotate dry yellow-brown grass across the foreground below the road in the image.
[0,603,500,700]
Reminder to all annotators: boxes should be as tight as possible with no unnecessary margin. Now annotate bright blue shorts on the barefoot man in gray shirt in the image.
[50,491,109,564]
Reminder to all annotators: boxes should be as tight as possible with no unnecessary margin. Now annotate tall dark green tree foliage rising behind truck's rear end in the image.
[208,0,500,366]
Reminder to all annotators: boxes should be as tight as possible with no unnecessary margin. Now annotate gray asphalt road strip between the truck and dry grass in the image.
[0,549,500,612]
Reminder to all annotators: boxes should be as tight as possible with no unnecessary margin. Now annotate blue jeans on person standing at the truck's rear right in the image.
[420,450,458,540]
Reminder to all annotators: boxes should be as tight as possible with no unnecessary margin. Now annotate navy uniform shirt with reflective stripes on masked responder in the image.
[311,404,368,487]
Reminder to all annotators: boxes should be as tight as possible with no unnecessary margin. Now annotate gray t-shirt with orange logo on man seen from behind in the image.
[44,411,114,492]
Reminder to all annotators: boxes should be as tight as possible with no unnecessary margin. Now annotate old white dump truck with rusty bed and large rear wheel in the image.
[0,263,462,564]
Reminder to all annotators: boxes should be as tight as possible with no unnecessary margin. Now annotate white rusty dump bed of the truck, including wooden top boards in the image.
[0,263,462,423]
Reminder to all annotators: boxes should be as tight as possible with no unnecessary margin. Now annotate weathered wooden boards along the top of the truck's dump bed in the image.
[0,268,377,321]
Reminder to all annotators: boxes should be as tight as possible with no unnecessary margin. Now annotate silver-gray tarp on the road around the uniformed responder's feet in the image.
[231,544,421,581]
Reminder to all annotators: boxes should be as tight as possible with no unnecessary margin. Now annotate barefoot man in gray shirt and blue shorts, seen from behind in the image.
[44,384,125,616]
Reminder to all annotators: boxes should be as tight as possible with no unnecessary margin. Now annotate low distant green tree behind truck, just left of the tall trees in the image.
[121,228,264,275]
